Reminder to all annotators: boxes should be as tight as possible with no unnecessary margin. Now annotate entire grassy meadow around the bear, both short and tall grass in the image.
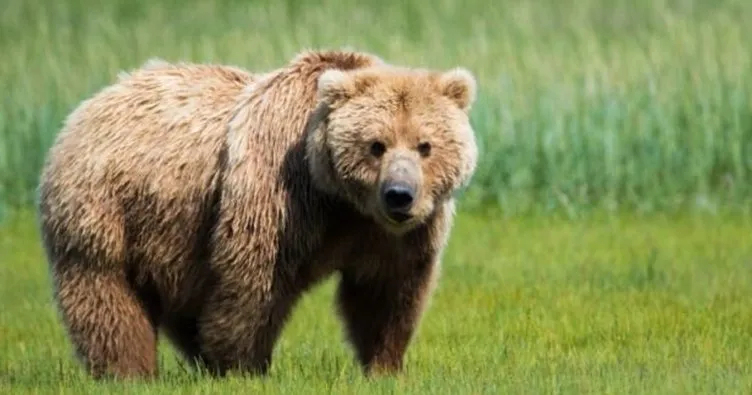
[0,0,752,394]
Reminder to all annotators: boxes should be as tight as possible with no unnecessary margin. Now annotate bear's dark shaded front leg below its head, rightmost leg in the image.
[337,259,436,375]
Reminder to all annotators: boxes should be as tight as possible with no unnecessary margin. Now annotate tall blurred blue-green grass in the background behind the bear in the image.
[0,0,752,214]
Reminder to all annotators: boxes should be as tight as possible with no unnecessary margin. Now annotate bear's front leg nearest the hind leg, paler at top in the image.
[198,176,300,376]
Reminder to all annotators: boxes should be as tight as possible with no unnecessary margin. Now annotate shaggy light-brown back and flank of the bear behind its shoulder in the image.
[39,60,255,280]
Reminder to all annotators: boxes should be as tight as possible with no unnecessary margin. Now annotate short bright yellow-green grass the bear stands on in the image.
[0,210,752,394]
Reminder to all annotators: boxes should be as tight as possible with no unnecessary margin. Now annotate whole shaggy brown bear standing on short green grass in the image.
[39,50,477,378]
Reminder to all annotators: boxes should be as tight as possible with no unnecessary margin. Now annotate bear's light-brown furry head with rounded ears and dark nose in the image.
[306,64,478,234]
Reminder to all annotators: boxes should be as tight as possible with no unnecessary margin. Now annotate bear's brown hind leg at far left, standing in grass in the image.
[55,262,157,379]
